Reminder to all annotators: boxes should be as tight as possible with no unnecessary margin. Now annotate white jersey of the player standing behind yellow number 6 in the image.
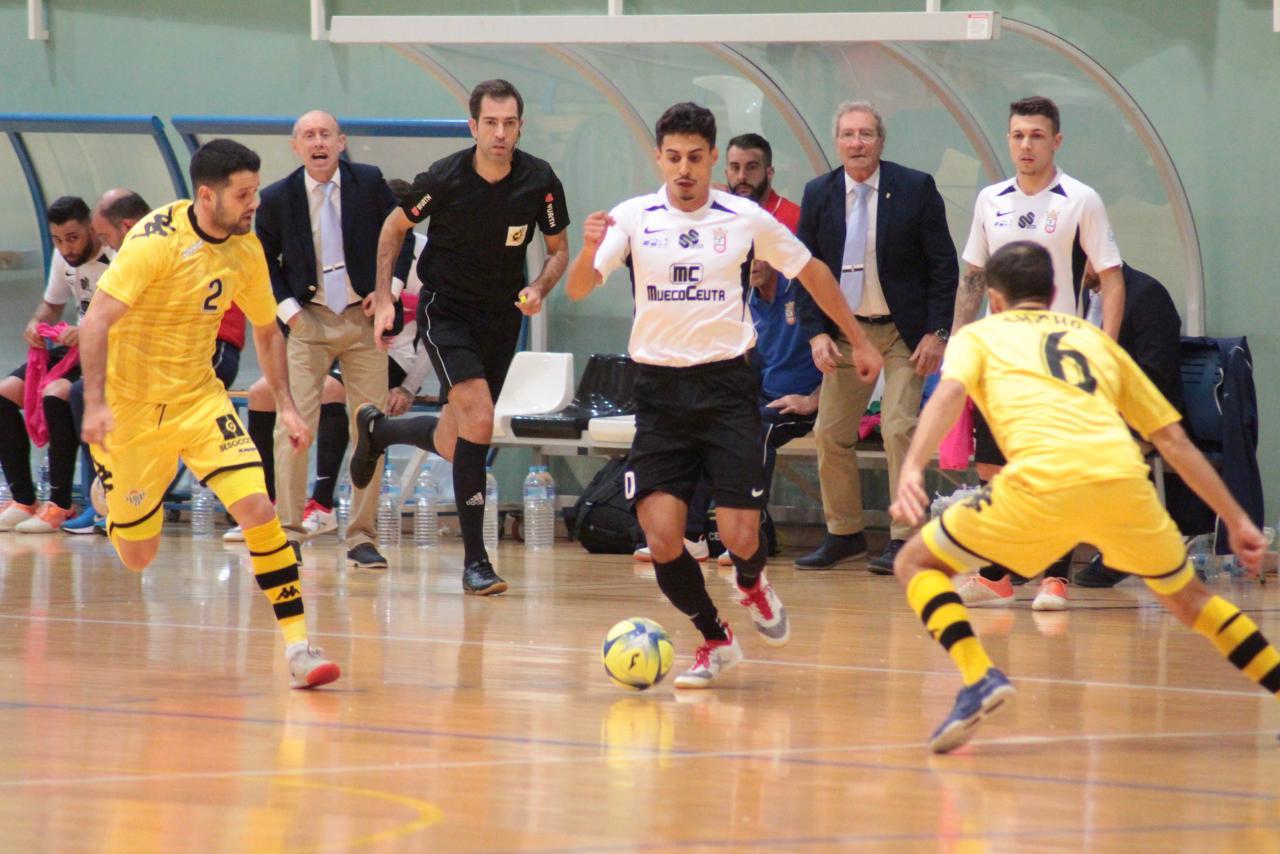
[964,170,1120,316]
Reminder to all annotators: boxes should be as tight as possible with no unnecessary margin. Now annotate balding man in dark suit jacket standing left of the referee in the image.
[256,110,412,570]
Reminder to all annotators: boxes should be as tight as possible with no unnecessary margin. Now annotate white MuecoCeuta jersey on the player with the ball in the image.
[595,187,810,367]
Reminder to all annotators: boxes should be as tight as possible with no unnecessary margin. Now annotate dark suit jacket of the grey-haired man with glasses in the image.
[796,160,960,351]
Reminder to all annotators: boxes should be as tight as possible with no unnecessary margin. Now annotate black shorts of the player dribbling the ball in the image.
[625,359,768,510]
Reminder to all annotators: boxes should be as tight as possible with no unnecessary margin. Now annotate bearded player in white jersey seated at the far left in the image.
[0,196,110,534]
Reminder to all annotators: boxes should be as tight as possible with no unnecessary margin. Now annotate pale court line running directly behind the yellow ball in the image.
[0,613,1267,700]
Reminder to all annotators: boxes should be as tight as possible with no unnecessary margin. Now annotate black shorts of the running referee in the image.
[417,289,525,401]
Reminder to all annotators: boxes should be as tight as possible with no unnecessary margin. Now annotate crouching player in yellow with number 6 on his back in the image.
[890,241,1280,753]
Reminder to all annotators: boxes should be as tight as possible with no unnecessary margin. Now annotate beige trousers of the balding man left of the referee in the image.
[275,305,387,548]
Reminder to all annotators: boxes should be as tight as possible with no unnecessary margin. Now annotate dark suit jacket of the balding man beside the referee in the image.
[253,160,413,306]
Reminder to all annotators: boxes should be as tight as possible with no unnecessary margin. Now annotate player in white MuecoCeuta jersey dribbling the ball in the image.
[568,104,881,688]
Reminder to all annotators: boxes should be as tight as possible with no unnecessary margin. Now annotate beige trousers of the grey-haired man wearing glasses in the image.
[814,323,924,539]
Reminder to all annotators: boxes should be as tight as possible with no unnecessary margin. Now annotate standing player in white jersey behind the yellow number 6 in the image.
[952,96,1124,611]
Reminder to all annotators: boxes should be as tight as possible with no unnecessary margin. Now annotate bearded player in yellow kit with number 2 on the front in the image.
[79,140,339,688]
